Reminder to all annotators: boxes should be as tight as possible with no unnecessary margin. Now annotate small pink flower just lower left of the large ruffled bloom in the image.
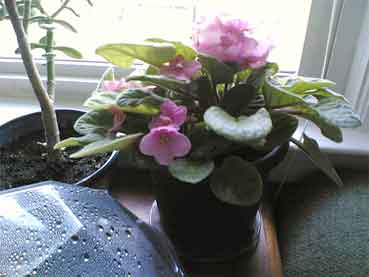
[160,55,201,81]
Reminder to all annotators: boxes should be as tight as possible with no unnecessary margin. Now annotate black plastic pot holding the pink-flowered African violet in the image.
[153,144,288,262]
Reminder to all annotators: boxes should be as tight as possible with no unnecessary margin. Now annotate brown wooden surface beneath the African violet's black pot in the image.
[105,169,283,277]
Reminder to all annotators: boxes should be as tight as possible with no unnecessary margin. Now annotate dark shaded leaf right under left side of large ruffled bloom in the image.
[199,55,235,84]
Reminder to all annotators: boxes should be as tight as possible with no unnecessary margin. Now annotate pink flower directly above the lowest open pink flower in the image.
[149,100,187,129]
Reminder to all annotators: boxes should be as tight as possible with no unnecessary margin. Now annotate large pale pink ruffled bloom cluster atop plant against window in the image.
[192,16,271,68]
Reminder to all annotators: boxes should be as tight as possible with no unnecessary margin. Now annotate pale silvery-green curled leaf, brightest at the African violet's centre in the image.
[204,106,272,144]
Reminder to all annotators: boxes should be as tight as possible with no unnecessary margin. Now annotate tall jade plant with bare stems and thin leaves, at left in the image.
[0,0,92,161]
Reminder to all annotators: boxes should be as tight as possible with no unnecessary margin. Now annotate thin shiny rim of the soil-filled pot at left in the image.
[0,108,119,186]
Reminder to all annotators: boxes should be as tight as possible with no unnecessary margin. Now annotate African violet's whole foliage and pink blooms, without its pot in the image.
[57,16,360,205]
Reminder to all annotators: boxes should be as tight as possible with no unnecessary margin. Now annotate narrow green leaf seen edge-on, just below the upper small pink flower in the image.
[127,75,189,93]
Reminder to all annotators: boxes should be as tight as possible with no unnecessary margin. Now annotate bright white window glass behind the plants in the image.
[0,0,311,71]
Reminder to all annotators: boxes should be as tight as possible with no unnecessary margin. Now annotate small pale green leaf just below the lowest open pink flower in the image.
[169,159,214,184]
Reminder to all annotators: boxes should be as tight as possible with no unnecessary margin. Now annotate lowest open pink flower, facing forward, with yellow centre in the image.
[139,126,191,165]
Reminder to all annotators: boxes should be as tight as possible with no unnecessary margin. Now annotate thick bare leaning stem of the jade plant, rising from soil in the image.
[5,0,61,161]
